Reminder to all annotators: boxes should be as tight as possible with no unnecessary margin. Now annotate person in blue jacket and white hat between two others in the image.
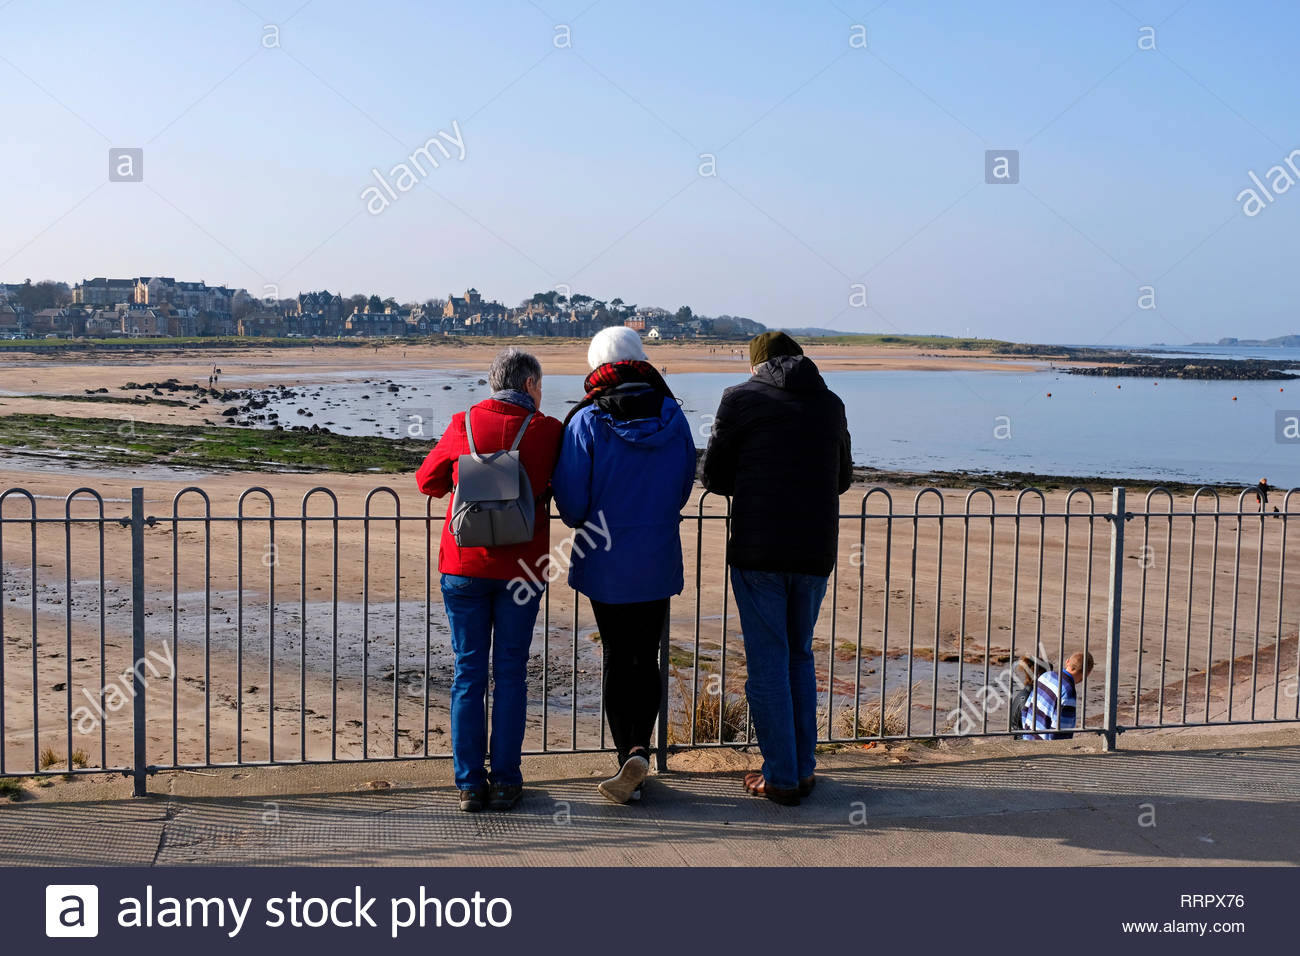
[551,325,696,804]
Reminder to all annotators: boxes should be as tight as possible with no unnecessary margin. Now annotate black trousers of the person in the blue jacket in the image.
[592,598,668,765]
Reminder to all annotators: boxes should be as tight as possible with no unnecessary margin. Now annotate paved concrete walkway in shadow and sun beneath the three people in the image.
[0,727,1300,866]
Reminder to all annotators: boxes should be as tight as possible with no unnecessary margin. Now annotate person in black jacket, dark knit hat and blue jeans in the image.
[703,332,853,806]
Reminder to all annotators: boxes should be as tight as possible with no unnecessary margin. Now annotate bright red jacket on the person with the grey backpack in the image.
[415,398,564,581]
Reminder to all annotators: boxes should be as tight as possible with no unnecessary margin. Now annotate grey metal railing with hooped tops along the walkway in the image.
[0,486,1300,792]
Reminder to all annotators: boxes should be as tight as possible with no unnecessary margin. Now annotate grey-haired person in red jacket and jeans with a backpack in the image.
[416,349,563,813]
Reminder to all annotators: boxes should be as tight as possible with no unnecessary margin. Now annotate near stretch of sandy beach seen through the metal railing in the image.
[0,472,1300,780]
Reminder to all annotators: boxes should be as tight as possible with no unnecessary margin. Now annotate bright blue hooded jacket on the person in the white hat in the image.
[551,398,696,604]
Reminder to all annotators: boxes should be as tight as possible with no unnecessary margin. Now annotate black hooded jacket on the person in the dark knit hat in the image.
[702,355,853,575]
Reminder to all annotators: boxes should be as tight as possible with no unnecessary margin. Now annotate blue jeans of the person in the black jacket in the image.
[731,567,827,790]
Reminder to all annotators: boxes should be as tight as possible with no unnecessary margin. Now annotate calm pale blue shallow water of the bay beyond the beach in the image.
[267,369,1300,488]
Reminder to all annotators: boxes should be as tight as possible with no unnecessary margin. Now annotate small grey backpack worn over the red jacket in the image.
[450,408,536,548]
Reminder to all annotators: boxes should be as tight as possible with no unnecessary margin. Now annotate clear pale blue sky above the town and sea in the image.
[0,0,1300,343]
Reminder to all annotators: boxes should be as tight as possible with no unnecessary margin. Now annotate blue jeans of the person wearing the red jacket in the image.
[442,575,541,790]
